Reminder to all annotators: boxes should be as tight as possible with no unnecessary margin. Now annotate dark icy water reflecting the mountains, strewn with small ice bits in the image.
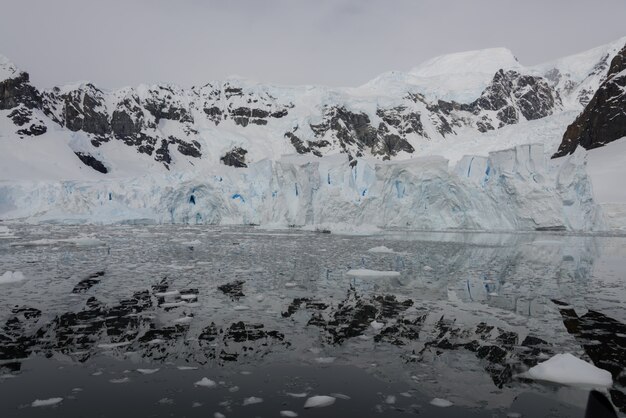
[0,225,626,417]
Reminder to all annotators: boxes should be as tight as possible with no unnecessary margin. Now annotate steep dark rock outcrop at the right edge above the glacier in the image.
[553,45,626,158]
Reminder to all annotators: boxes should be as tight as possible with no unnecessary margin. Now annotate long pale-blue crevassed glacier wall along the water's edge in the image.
[0,144,605,231]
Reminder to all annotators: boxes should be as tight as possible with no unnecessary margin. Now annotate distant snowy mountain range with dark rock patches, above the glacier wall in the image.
[0,40,624,179]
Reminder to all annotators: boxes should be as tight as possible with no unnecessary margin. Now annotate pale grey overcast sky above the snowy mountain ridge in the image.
[0,0,626,88]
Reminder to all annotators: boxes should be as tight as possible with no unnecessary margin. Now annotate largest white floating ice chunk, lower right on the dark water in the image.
[523,353,613,387]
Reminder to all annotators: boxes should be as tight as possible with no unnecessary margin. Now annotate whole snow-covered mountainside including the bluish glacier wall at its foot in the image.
[0,38,626,229]
